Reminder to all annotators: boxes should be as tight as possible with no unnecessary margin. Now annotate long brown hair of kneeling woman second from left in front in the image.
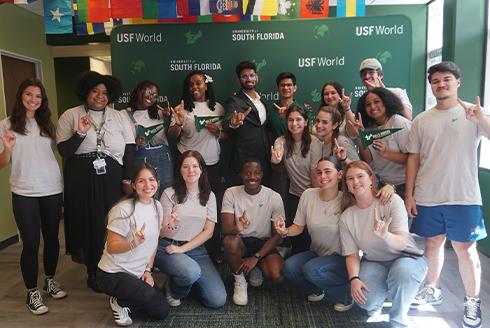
[172,150,211,206]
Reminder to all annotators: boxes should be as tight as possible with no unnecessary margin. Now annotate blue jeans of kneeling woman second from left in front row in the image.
[155,238,226,308]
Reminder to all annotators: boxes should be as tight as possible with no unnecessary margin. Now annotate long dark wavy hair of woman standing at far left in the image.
[10,78,56,140]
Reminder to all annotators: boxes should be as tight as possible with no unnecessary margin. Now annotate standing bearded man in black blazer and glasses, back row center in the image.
[222,60,271,186]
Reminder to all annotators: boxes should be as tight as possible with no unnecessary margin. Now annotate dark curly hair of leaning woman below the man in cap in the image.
[356,88,403,127]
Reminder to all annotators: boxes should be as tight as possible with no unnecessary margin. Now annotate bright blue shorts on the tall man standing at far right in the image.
[411,205,487,243]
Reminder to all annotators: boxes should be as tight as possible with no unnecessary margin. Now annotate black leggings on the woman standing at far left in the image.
[12,193,62,289]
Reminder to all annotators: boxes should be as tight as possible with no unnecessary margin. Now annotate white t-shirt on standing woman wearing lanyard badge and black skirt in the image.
[56,105,134,165]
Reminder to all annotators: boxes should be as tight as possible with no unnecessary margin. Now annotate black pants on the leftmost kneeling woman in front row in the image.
[97,268,168,320]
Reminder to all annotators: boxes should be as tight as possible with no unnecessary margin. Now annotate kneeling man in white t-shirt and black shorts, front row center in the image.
[221,159,284,305]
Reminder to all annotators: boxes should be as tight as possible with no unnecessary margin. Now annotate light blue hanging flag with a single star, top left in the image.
[44,0,73,34]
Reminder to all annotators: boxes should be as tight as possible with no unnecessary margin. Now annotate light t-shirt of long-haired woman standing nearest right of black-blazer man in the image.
[274,135,323,197]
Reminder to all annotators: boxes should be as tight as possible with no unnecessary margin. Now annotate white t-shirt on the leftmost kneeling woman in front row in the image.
[99,199,163,278]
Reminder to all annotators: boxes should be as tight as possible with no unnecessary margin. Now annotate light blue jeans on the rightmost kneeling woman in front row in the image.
[359,256,427,327]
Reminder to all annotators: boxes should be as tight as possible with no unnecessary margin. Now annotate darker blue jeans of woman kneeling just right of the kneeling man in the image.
[282,251,349,302]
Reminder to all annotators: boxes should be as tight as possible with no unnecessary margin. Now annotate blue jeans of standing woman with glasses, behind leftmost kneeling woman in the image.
[133,145,174,198]
